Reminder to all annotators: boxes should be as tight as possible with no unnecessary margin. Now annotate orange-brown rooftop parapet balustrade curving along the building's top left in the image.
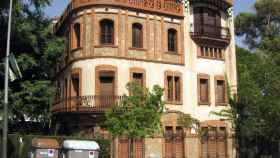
[54,0,183,32]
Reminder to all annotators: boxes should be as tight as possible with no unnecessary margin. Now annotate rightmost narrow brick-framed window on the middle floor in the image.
[216,80,226,104]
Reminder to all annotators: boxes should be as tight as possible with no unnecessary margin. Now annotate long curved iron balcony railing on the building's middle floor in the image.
[50,96,125,113]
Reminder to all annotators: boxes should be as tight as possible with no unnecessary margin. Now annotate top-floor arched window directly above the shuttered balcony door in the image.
[100,19,114,44]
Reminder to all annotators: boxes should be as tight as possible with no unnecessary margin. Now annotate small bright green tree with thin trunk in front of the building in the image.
[105,83,164,157]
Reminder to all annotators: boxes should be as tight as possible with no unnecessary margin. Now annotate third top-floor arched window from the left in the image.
[132,23,143,48]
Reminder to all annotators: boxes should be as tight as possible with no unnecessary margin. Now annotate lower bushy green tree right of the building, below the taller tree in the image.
[215,45,280,158]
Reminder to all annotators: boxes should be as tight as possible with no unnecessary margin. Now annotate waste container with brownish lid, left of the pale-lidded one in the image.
[30,138,59,158]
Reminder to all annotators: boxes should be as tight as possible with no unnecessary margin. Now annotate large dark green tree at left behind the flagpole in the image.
[0,0,64,133]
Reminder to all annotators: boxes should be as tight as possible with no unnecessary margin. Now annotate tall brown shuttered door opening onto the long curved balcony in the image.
[99,71,115,107]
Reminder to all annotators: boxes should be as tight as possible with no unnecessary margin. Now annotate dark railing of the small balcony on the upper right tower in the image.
[191,24,230,40]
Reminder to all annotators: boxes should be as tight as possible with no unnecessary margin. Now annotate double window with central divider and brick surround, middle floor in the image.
[165,72,182,104]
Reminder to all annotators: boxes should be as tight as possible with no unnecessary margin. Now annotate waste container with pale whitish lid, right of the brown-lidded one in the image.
[62,140,100,158]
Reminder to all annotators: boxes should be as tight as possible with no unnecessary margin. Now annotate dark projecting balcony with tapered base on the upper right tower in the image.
[190,24,231,46]
